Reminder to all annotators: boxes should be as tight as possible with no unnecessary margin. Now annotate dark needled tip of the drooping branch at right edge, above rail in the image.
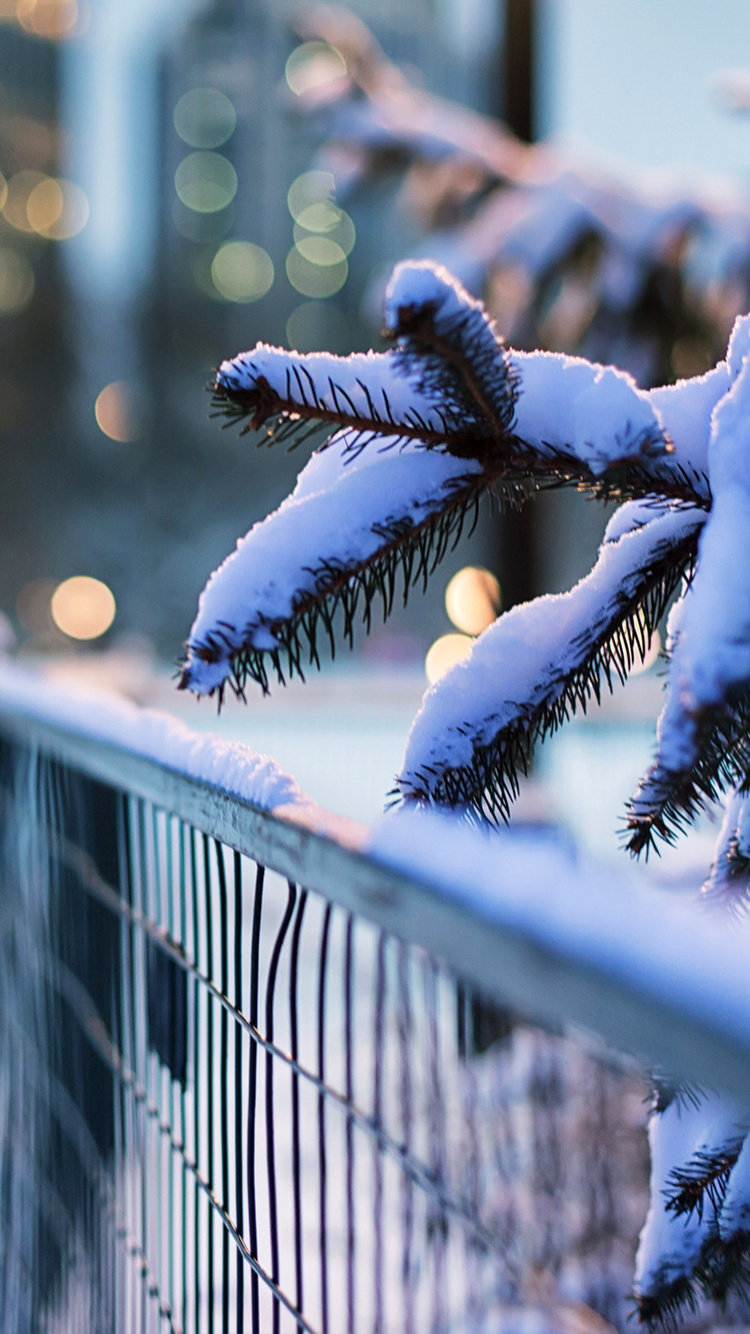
[626,690,750,856]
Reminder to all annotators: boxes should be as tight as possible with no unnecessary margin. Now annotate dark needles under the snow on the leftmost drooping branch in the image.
[177,474,486,706]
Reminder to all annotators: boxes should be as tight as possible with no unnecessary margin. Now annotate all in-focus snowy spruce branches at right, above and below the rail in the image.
[180,261,750,1323]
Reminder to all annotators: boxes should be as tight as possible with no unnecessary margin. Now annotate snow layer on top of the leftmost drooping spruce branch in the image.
[185,432,480,694]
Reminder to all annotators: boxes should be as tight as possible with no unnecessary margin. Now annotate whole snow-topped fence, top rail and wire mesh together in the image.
[0,668,750,1334]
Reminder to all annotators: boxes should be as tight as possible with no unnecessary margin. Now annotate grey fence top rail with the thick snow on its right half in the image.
[0,667,750,1103]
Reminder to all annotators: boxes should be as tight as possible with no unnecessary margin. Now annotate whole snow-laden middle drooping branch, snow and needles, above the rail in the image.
[398,503,705,820]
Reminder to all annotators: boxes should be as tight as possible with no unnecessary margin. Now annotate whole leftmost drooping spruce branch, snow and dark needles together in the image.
[180,432,486,698]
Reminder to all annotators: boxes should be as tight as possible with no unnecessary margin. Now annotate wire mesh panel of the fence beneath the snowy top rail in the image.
[0,743,647,1334]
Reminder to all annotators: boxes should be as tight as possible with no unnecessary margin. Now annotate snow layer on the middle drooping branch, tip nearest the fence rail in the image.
[399,507,705,791]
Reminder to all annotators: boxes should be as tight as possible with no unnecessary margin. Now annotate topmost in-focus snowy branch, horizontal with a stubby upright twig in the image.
[214,261,707,504]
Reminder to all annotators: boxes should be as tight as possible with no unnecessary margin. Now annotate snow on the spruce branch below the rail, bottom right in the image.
[635,1094,747,1297]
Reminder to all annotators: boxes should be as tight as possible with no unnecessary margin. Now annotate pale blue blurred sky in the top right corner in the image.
[540,0,750,184]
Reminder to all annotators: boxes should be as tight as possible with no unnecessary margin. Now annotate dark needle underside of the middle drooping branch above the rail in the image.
[390,520,699,823]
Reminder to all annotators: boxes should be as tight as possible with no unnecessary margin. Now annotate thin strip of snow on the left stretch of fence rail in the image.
[0,662,311,810]
